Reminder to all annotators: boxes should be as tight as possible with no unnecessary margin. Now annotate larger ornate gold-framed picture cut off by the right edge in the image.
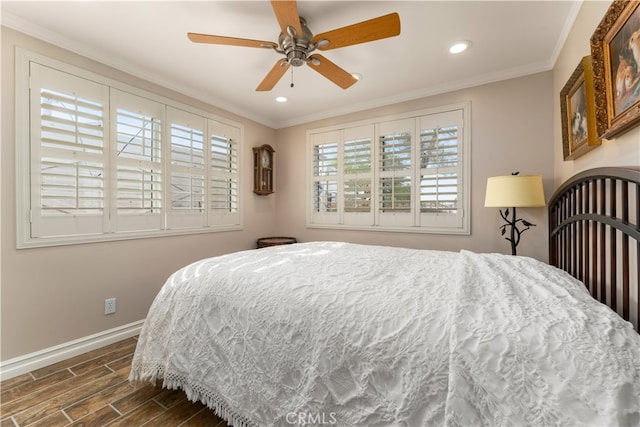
[591,0,640,139]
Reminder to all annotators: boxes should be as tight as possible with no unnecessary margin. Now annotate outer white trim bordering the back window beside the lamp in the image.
[305,101,472,235]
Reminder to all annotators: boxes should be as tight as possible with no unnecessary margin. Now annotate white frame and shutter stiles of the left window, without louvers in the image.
[15,47,244,249]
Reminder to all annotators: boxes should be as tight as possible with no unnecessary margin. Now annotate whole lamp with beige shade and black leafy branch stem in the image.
[484,172,545,255]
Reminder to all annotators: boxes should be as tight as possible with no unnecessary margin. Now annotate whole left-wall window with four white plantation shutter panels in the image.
[16,50,242,247]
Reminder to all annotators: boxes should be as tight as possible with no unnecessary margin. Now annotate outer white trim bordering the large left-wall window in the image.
[14,47,244,249]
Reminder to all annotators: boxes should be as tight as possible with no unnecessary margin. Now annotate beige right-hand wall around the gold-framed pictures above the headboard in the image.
[553,1,640,186]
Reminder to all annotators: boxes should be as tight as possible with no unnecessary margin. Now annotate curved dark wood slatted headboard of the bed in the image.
[549,167,640,332]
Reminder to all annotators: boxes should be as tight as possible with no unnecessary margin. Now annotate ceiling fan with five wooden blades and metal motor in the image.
[187,0,400,91]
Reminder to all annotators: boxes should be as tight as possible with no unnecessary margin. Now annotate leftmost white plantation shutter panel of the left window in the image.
[30,63,108,238]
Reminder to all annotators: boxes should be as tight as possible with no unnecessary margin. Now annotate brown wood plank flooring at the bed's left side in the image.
[0,337,227,427]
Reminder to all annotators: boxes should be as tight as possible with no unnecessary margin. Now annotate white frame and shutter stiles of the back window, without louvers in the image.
[305,101,471,235]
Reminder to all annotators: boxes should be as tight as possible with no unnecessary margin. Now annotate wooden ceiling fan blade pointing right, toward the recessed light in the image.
[313,13,400,50]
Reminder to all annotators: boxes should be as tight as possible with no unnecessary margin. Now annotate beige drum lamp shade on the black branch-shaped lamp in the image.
[484,175,545,208]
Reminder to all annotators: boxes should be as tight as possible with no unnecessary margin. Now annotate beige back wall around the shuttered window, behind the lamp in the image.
[276,72,555,260]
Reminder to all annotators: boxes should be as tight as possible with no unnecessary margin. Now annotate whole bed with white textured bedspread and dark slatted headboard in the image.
[130,169,640,426]
